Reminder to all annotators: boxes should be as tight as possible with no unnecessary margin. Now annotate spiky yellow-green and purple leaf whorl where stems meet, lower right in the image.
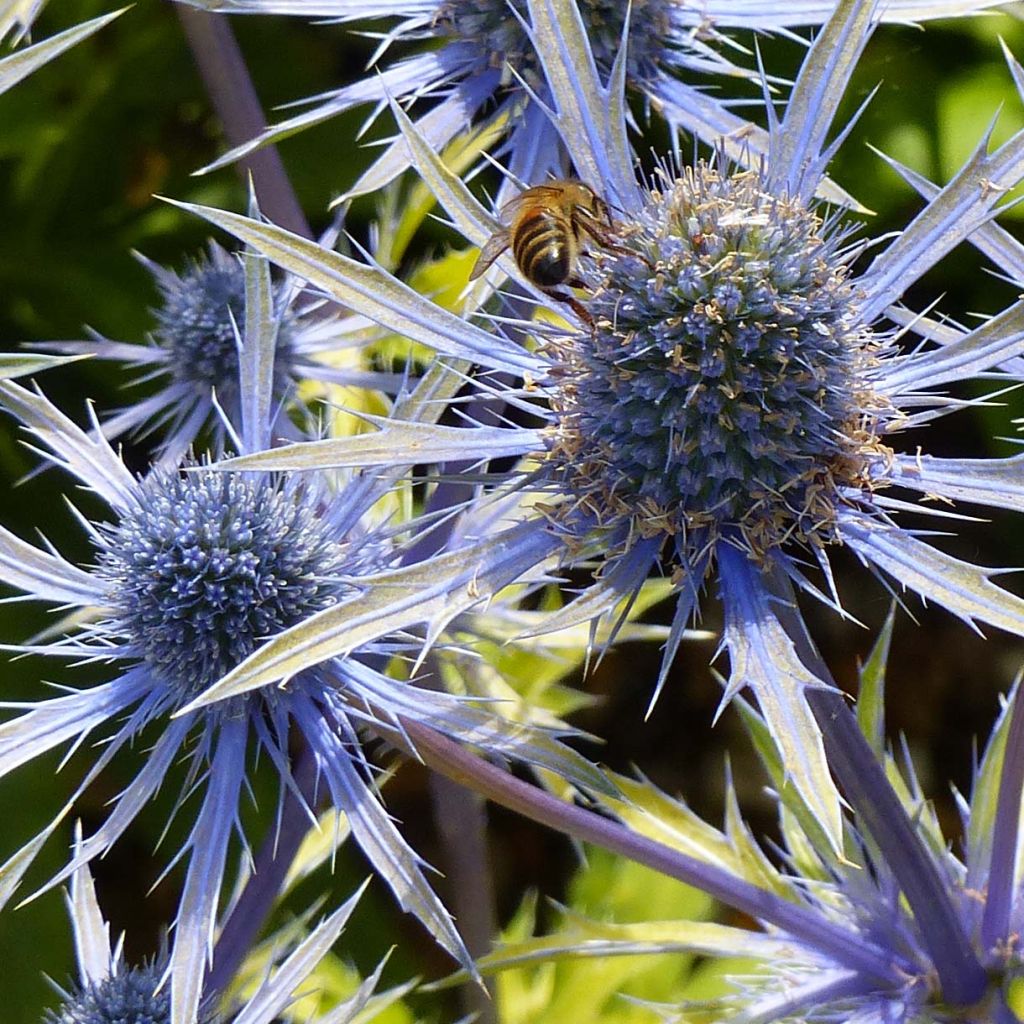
[456,616,1024,1024]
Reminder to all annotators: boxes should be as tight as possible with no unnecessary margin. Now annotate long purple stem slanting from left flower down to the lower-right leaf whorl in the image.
[401,719,902,987]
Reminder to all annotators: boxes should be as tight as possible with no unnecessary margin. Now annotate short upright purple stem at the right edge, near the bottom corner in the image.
[981,680,1024,949]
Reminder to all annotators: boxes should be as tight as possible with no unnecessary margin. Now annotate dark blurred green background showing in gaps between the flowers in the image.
[0,0,1024,1024]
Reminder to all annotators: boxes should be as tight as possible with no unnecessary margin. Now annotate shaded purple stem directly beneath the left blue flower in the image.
[204,748,316,1002]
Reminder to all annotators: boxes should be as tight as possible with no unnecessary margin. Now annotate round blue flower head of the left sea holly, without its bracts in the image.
[97,468,348,707]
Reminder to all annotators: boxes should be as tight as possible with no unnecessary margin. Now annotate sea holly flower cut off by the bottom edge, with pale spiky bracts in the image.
[44,865,389,1024]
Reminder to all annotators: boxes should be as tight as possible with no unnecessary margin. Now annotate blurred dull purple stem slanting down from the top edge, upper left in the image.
[174,3,313,239]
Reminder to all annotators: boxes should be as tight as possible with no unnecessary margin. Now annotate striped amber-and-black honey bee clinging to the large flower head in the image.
[469,180,616,322]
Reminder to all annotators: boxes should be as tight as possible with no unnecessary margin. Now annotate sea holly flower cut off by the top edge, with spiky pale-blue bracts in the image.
[169,0,991,198]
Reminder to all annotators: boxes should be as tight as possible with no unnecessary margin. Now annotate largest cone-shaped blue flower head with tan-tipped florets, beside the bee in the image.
[547,161,888,565]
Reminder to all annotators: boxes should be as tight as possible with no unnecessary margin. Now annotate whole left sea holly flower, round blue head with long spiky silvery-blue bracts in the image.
[0,247,607,1024]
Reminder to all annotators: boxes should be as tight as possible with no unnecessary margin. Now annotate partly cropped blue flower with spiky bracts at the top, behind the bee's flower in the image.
[184,0,753,196]
